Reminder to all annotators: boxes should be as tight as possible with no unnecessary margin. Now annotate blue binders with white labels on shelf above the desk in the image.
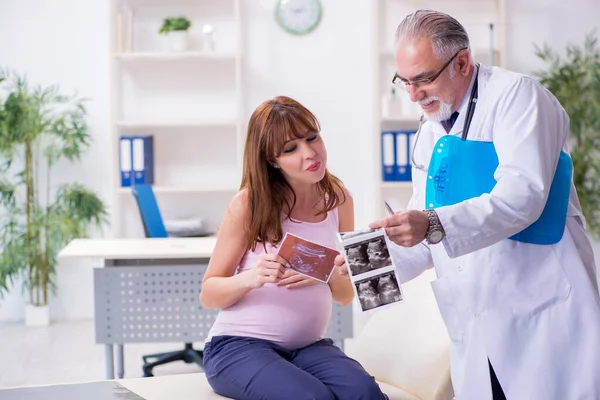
[119,136,154,187]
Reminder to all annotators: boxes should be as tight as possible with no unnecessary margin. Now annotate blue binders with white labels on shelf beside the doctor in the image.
[381,131,415,182]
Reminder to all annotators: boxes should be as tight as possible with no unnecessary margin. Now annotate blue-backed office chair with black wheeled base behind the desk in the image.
[133,185,203,377]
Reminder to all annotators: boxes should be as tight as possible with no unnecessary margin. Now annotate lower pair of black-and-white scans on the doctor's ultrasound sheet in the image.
[354,272,402,311]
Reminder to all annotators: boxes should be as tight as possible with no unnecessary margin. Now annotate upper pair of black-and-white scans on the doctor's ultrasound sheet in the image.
[346,237,392,275]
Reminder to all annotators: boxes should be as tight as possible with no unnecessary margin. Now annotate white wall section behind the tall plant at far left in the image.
[0,0,112,321]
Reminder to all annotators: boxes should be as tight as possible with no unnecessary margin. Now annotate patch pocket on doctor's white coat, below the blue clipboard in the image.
[495,242,571,318]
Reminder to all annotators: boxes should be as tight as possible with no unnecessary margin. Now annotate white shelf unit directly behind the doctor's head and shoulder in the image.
[372,0,506,218]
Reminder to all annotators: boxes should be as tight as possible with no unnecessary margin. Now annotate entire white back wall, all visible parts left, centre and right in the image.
[0,0,600,321]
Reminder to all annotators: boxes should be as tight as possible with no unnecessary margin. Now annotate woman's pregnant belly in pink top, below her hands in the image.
[212,283,332,349]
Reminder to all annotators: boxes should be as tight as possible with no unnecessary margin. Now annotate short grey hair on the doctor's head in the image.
[395,10,473,63]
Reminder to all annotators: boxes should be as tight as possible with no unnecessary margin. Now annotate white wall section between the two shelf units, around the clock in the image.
[243,0,375,225]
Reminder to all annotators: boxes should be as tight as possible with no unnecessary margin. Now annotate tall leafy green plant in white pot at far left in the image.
[0,71,107,326]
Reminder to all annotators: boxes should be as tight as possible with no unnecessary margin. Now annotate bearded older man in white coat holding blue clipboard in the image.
[336,10,600,400]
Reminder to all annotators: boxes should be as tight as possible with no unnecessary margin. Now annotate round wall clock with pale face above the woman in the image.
[275,0,323,35]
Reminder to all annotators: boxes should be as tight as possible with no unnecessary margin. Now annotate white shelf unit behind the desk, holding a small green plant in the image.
[110,0,244,237]
